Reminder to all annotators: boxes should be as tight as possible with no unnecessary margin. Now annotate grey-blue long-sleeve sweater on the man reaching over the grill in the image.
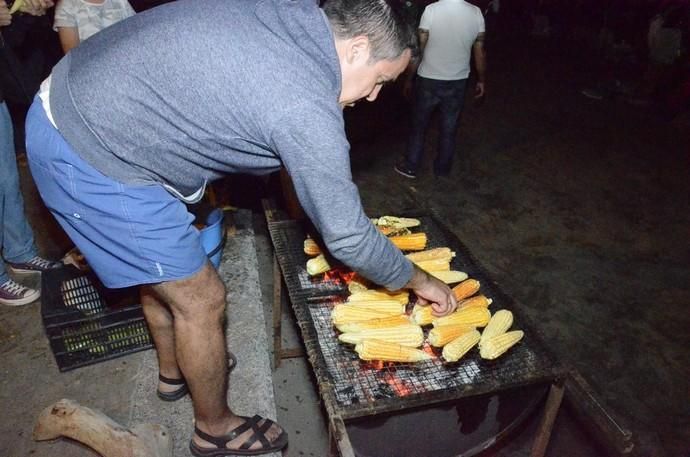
[50,0,413,289]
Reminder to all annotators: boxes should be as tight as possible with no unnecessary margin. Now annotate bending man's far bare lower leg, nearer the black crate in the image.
[139,285,182,393]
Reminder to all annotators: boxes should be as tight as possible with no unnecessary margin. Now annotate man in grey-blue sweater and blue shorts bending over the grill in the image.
[22,0,457,456]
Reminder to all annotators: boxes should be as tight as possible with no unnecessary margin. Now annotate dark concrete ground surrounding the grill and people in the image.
[0,23,690,457]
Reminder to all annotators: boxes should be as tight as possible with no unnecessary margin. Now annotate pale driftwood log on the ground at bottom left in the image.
[33,399,172,457]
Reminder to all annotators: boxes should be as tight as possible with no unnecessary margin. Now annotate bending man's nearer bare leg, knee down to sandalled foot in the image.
[153,262,282,449]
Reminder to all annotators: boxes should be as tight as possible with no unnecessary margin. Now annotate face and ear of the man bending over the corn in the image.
[339,38,410,108]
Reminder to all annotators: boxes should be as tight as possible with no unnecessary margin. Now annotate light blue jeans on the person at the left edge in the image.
[0,102,37,284]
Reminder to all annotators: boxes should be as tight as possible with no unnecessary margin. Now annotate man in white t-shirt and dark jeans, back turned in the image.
[395,0,486,178]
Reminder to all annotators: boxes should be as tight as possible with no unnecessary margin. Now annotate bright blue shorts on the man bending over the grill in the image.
[26,97,208,288]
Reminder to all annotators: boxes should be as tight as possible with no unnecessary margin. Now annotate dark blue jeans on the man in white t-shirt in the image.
[406,76,467,176]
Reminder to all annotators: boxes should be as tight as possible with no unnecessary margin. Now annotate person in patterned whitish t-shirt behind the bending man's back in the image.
[53,0,135,54]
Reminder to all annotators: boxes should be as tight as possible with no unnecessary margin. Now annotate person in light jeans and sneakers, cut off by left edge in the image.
[0,0,61,306]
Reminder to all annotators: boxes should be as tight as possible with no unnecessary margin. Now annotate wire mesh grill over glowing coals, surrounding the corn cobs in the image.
[269,216,555,419]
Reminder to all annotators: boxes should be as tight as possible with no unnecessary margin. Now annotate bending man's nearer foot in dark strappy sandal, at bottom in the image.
[189,416,288,457]
